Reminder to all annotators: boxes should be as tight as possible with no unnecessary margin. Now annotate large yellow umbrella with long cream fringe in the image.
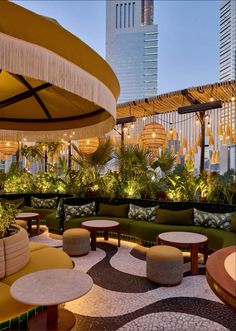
[0,1,119,141]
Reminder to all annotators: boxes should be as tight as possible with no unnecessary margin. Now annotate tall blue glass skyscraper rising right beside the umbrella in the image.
[106,0,158,103]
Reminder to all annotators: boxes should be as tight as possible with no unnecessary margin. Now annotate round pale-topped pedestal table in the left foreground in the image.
[10,269,93,330]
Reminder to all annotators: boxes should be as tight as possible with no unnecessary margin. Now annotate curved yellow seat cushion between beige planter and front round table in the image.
[2,247,73,285]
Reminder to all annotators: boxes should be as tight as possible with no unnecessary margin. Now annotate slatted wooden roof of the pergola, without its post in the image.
[117,80,236,118]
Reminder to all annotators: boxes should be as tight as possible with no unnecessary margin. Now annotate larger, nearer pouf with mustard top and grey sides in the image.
[146,245,183,286]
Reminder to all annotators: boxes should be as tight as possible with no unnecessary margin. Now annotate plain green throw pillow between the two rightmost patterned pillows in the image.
[154,208,193,225]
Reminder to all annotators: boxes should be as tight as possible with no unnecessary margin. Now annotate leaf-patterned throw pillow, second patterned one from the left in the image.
[64,202,96,222]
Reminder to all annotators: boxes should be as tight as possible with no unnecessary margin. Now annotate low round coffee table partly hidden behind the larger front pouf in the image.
[157,231,208,275]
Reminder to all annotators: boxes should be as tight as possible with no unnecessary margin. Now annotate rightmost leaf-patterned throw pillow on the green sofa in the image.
[193,208,234,231]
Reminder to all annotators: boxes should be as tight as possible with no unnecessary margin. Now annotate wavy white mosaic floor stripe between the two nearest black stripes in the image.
[65,276,221,317]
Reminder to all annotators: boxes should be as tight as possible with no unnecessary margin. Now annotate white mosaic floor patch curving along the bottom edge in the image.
[118,312,228,331]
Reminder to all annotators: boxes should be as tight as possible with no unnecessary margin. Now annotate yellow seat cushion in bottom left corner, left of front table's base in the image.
[0,282,34,323]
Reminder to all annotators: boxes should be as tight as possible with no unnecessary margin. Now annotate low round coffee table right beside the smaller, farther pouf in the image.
[81,220,120,251]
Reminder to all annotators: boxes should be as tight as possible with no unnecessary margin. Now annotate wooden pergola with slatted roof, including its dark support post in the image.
[117,80,236,172]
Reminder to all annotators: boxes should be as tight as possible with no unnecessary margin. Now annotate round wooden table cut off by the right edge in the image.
[206,245,236,310]
